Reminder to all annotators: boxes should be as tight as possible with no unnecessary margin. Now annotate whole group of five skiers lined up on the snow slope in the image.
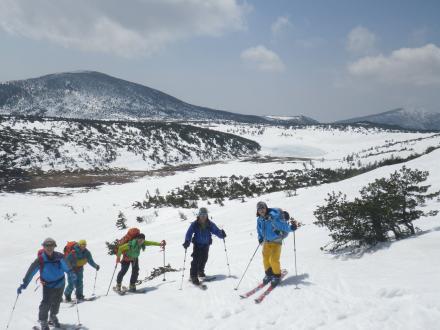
[17,202,298,330]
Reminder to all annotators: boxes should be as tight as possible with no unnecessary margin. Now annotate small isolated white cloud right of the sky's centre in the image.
[240,45,285,72]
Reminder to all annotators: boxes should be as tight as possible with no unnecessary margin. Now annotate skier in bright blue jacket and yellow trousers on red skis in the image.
[257,202,298,286]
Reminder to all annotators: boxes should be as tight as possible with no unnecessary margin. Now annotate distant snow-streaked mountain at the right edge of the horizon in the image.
[337,108,440,130]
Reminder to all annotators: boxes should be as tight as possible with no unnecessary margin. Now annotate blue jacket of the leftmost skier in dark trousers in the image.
[23,252,72,288]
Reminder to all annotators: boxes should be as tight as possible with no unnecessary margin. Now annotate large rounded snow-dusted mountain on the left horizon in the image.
[0,71,316,124]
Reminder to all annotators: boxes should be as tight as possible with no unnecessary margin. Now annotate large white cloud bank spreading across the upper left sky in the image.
[0,0,249,56]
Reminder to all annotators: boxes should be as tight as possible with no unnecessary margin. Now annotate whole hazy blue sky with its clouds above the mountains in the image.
[0,0,440,121]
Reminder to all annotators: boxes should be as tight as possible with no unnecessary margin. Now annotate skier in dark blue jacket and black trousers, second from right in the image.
[183,207,226,285]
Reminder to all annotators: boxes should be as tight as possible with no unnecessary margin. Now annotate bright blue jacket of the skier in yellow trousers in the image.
[257,208,293,243]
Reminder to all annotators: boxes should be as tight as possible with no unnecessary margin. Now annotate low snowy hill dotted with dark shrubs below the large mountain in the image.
[0,117,260,173]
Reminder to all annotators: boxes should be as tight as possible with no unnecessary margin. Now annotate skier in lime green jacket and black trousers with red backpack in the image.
[114,228,166,292]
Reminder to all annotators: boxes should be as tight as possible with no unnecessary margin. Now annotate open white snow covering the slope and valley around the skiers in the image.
[0,124,440,330]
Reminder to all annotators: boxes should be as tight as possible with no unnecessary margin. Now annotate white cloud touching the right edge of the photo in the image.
[348,44,440,86]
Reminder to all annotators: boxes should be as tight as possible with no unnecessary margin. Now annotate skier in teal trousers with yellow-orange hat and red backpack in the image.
[64,239,99,302]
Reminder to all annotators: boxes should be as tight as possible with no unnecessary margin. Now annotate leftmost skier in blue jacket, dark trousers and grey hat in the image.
[17,238,76,330]
